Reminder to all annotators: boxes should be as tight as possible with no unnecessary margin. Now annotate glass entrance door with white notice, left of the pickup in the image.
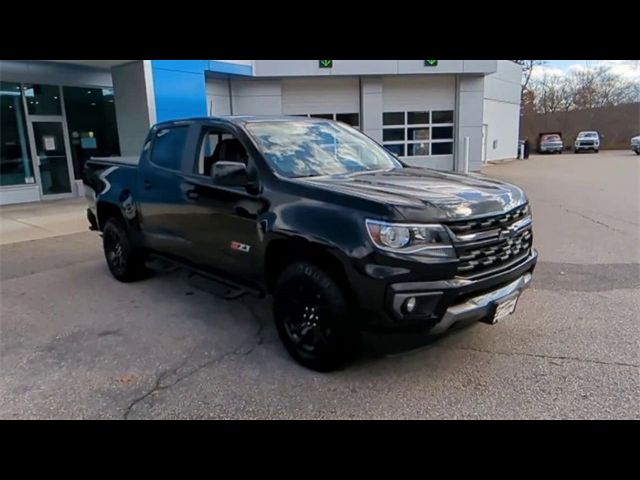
[29,117,73,199]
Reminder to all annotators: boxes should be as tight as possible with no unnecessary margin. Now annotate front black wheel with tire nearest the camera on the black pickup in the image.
[273,262,360,372]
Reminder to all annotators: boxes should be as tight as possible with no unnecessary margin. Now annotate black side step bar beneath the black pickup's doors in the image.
[146,254,264,300]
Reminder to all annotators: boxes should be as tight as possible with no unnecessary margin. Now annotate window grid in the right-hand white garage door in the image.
[382,110,454,157]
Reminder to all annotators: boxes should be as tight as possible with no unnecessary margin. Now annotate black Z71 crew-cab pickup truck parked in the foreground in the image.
[84,116,537,371]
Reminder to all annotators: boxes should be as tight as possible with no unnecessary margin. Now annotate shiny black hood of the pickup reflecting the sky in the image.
[300,167,526,221]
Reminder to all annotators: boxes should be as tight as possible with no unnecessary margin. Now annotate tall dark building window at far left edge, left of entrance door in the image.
[0,82,35,186]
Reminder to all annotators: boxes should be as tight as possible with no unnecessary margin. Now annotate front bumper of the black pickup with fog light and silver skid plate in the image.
[352,249,538,333]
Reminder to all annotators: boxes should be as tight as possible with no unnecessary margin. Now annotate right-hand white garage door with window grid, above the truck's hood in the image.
[382,75,455,170]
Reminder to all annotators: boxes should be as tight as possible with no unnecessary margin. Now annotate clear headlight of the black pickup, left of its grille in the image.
[366,219,455,258]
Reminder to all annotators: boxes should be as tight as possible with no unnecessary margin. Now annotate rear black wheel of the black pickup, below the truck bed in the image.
[102,218,147,282]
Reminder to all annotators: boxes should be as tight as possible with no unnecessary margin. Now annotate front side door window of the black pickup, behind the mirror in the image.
[196,128,248,177]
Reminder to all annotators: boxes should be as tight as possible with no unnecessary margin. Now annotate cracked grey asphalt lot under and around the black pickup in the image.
[0,151,640,419]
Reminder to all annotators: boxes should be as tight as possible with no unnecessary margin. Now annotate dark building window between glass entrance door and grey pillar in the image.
[63,87,120,179]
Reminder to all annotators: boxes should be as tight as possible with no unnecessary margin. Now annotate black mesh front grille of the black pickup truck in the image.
[447,205,533,278]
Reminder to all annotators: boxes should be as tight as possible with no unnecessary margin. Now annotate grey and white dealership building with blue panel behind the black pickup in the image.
[0,60,522,205]
